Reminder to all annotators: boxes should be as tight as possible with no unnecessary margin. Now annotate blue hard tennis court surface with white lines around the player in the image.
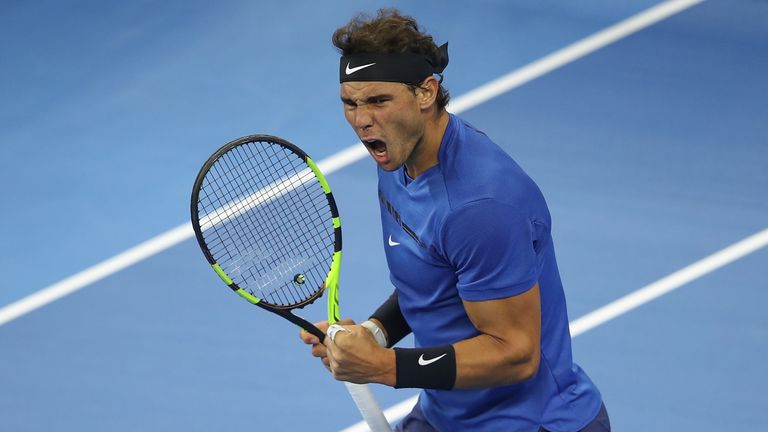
[0,0,768,432]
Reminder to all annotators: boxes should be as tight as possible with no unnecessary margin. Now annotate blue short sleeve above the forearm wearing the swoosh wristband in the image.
[441,199,538,301]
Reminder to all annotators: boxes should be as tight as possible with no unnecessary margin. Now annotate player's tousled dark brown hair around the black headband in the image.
[332,8,451,109]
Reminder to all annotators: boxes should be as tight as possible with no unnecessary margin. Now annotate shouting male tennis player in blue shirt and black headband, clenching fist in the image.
[301,9,610,432]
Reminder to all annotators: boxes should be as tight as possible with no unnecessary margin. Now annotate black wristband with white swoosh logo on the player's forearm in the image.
[395,345,456,390]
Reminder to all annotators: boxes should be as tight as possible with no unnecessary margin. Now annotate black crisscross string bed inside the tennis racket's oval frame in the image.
[198,142,334,306]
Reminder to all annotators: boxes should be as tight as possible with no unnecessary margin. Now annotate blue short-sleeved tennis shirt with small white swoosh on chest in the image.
[378,115,601,432]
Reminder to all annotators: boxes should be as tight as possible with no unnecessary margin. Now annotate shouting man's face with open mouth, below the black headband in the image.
[341,81,425,171]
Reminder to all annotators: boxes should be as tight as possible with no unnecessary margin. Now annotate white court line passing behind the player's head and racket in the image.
[0,0,703,325]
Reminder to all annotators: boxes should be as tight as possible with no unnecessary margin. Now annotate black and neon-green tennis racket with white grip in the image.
[191,135,391,432]
